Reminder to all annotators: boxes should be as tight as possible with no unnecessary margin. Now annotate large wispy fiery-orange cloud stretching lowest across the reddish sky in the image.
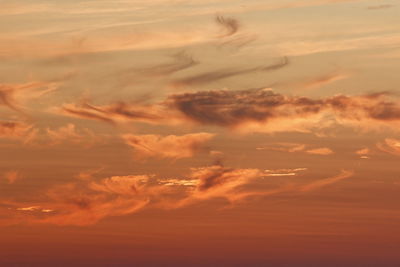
[0,165,353,226]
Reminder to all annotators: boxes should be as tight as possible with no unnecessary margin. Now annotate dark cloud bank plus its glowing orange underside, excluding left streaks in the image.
[167,89,400,132]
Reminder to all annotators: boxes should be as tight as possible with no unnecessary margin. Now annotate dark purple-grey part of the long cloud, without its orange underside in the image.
[167,89,400,127]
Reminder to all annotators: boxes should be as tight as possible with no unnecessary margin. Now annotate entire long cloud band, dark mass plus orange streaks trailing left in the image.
[58,89,400,135]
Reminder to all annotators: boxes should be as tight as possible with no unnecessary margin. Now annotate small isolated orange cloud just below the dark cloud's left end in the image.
[123,133,214,159]
